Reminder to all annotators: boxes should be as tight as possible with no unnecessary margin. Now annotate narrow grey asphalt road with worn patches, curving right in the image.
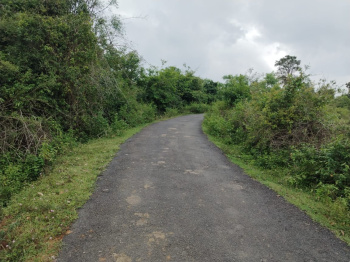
[58,115,350,262]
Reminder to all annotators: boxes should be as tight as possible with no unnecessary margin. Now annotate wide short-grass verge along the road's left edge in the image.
[0,125,145,262]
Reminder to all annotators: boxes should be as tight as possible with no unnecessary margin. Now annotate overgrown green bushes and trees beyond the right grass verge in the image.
[204,56,350,242]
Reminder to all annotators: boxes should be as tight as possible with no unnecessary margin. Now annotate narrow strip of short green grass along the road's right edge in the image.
[203,125,350,245]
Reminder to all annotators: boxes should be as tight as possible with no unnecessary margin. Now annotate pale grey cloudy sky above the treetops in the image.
[116,0,350,86]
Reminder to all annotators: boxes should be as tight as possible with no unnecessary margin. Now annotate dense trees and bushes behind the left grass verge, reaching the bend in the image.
[0,0,216,210]
